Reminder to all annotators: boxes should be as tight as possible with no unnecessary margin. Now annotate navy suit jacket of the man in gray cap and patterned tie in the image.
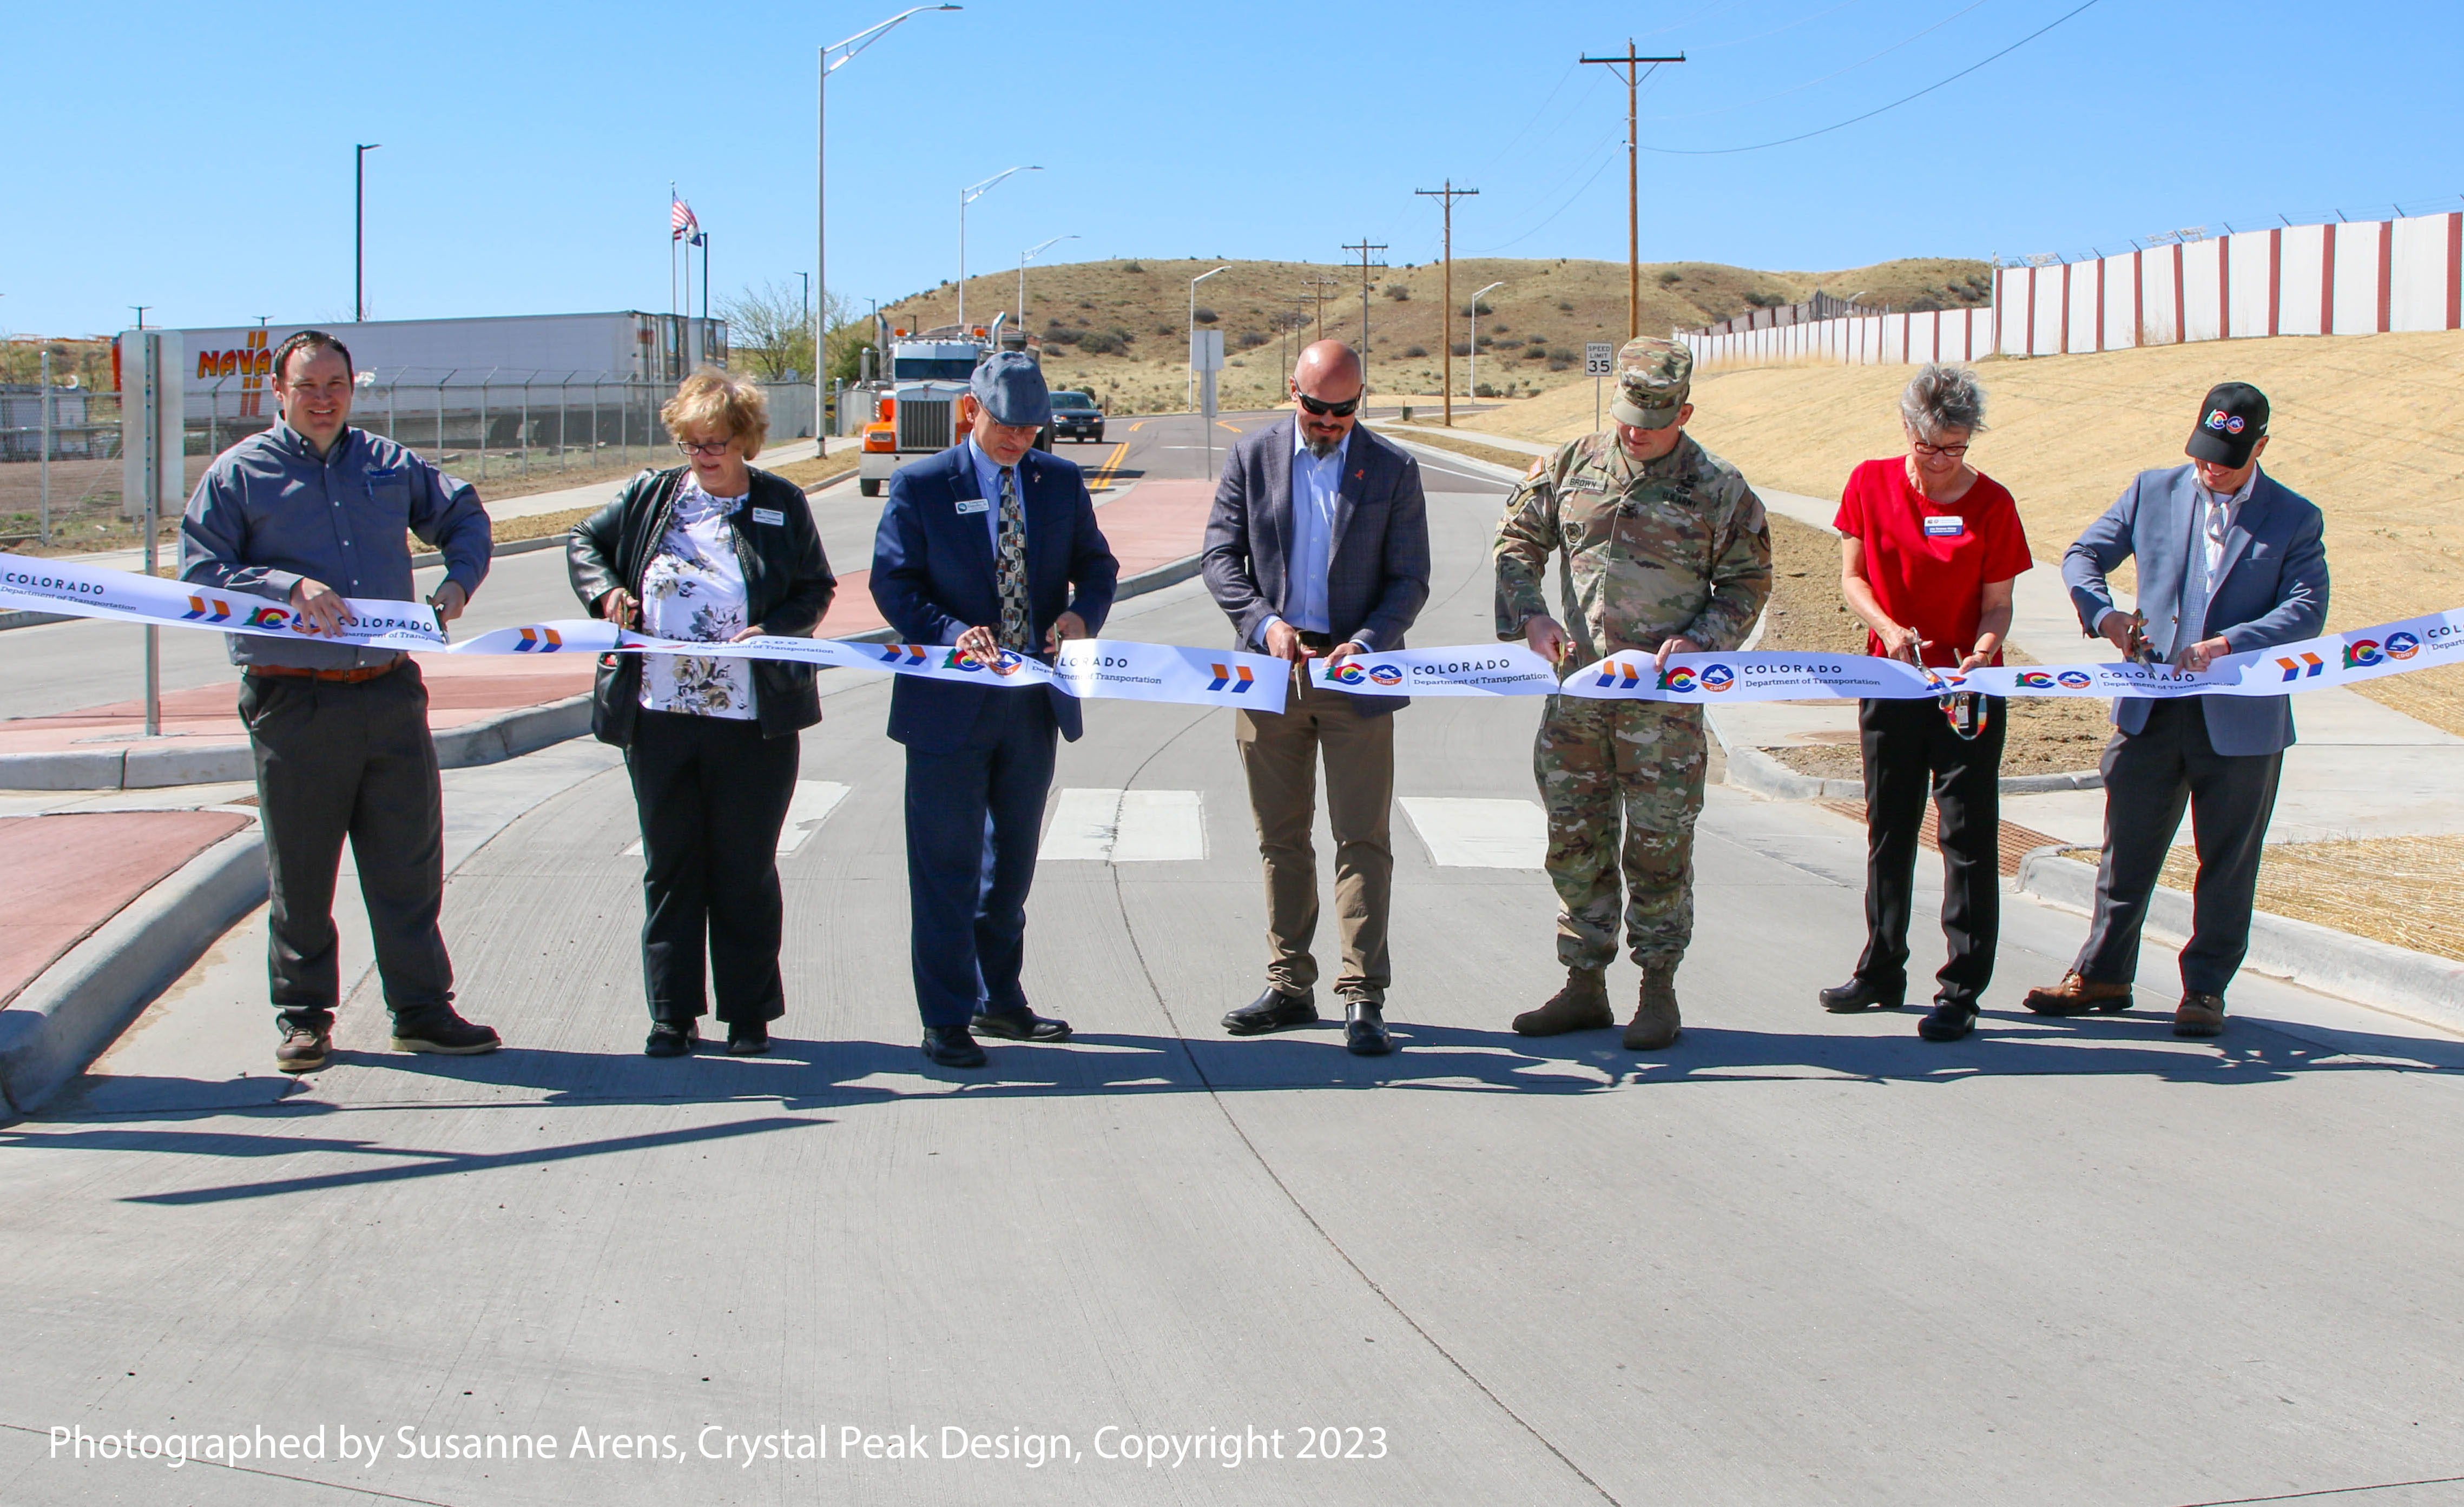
[872,446,1121,754]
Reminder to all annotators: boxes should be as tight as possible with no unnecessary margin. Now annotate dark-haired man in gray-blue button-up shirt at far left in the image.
[180,330,498,1074]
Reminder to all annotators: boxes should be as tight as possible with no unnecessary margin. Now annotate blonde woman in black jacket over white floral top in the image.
[566,367,838,1056]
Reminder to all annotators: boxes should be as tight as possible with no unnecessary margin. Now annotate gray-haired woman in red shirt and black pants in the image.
[1821,365,2030,1042]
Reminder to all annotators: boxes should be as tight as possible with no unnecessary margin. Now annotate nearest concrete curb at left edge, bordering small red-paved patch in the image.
[0,825,266,1115]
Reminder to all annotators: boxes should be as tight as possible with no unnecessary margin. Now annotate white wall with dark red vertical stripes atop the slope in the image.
[1681,211,2464,367]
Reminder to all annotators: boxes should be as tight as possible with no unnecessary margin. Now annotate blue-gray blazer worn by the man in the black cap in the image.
[2063,465,2326,754]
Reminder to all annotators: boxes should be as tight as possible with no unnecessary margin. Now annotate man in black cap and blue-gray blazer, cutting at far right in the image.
[2028,382,2326,1037]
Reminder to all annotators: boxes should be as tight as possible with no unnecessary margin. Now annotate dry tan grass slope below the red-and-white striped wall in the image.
[1456,333,2464,734]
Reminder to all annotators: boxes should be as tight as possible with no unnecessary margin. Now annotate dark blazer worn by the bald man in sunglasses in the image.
[1202,414,1429,717]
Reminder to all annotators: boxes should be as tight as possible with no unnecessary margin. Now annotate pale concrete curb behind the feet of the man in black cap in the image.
[2018,847,2464,1032]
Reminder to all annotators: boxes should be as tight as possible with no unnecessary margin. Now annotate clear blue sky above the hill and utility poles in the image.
[0,0,2464,335]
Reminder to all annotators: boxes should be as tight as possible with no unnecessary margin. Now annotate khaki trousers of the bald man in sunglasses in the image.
[1237,685,1395,1007]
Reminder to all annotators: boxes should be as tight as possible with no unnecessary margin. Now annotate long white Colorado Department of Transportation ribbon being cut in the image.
[0,554,2464,712]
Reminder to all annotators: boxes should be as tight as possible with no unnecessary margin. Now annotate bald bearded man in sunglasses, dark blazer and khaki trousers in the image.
[1205,340,1429,1056]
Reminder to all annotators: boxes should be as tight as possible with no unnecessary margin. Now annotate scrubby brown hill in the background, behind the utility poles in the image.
[882,256,1988,411]
